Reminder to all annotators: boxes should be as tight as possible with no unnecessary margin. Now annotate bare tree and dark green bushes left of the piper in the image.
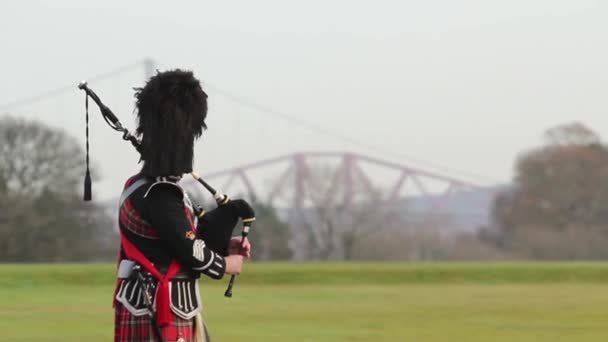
[0,116,116,262]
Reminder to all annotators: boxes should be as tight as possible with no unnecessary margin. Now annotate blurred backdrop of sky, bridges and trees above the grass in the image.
[0,0,608,261]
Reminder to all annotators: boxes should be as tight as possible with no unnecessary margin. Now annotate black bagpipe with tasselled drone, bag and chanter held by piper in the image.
[78,81,255,297]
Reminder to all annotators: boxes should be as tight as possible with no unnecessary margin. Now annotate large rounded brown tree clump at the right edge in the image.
[479,123,608,259]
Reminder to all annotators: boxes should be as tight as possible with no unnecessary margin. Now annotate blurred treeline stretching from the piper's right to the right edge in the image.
[245,123,608,260]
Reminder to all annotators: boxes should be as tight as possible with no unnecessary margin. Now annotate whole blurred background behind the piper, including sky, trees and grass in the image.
[0,0,608,342]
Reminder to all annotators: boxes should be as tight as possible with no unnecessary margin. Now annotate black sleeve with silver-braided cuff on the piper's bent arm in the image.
[144,183,226,279]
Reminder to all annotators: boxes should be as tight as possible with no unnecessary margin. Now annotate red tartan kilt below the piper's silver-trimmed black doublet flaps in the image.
[114,303,194,342]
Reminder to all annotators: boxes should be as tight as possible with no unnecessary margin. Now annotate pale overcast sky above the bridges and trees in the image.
[0,0,608,197]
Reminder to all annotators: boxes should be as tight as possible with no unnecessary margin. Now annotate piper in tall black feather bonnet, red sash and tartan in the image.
[114,69,251,342]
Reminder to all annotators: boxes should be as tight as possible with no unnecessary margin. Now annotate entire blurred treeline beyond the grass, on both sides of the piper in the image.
[0,117,608,262]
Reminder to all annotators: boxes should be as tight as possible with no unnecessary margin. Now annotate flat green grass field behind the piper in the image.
[0,263,608,342]
